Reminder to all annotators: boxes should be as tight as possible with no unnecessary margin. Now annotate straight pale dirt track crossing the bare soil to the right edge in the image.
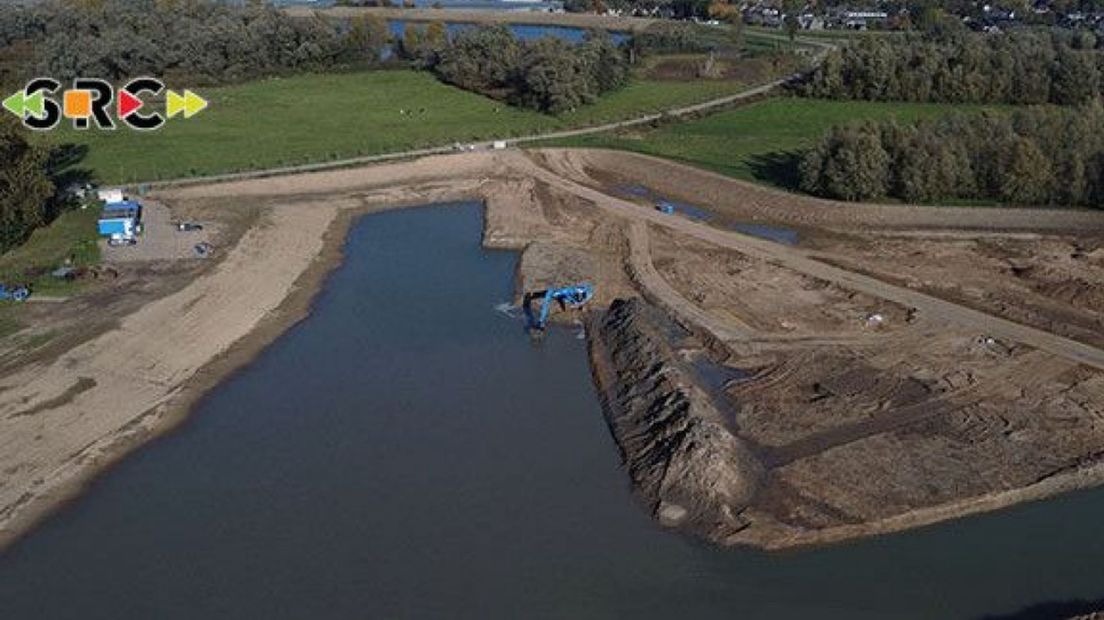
[519,158,1104,370]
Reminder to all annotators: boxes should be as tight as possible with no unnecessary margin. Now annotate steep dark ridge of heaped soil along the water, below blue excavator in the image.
[592,299,763,541]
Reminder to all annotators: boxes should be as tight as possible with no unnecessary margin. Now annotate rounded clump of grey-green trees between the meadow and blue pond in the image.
[427,25,628,114]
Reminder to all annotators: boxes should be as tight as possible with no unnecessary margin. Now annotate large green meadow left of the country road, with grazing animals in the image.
[60,71,768,183]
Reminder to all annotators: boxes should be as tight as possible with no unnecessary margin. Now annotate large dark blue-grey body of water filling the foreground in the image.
[0,203,1104,620]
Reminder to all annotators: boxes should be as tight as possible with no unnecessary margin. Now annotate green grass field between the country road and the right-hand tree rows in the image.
[548,97,999,189]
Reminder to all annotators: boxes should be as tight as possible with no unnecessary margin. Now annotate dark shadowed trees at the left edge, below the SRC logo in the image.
[0,115,54,253]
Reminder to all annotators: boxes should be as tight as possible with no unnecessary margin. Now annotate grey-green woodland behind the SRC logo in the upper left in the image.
[0,0,379,83]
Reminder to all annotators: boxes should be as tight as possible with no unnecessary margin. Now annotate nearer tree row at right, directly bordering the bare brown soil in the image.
[799,101,1104,209]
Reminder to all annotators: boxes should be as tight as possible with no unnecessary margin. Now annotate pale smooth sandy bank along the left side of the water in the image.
[0,198,338,544]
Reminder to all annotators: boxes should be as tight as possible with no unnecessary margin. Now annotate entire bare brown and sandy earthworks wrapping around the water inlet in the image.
[0,145,1104,548]
